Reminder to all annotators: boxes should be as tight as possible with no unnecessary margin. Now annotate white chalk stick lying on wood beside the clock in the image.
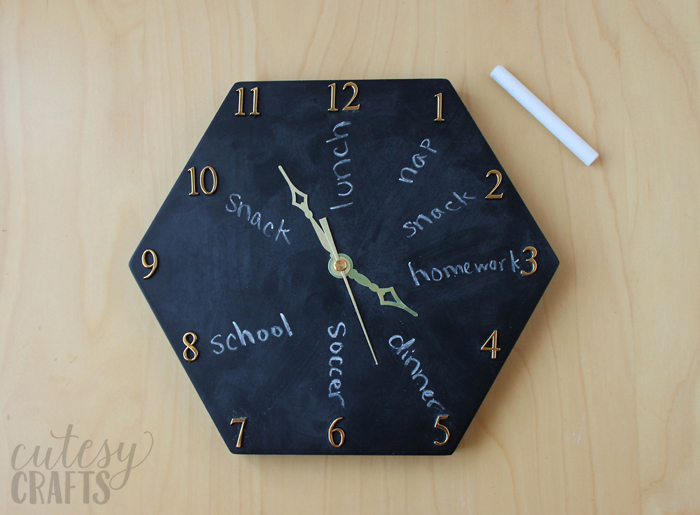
[491,65,598,166]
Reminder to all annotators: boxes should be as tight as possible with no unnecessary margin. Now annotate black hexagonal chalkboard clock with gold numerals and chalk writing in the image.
[130,79,558,454]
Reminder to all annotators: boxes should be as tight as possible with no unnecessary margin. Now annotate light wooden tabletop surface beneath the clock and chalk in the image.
[0,0,700,515]
